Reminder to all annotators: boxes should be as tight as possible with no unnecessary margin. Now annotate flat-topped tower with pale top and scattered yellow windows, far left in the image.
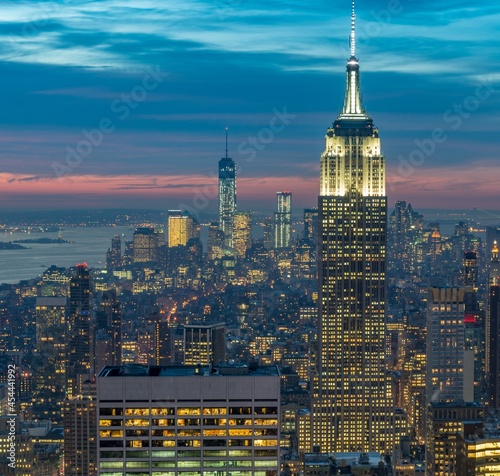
[33,297,68,422]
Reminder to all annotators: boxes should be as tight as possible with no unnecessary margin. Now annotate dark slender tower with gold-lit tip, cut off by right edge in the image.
[485,241,500,409]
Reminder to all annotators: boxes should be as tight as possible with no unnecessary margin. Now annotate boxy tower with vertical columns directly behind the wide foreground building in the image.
[184,323,226,365]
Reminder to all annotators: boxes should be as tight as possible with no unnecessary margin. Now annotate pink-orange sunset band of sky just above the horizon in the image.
[0,164,500,209]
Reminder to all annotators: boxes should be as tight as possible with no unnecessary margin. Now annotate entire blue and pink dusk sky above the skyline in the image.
[0,0,500,214]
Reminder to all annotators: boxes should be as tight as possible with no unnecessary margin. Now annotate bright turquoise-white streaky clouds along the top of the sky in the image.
[0,0,500,80]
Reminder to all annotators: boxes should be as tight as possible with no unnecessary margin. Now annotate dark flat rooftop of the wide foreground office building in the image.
[98,364,279,377]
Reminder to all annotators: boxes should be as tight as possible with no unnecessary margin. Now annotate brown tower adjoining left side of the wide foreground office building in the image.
[64,384,96,476]
